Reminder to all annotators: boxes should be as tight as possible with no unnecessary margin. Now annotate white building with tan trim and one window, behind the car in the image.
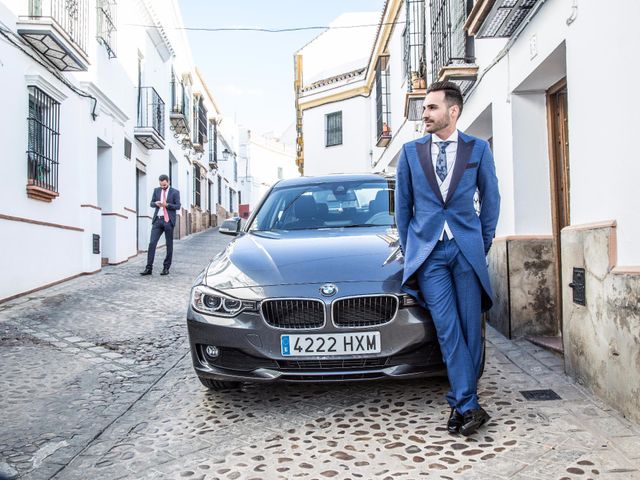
[295,12,380,175]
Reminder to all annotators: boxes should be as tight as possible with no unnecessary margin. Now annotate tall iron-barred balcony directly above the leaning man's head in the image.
[431,0,478,94]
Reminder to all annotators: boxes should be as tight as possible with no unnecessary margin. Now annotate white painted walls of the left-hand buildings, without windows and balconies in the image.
[0,0,238,300]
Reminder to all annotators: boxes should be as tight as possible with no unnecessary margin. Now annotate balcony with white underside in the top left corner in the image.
[16,0,89,72]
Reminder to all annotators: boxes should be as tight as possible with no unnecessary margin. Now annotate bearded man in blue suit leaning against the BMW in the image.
[395,82,500,435]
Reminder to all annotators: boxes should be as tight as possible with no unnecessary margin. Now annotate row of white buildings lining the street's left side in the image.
[0,0,238,300]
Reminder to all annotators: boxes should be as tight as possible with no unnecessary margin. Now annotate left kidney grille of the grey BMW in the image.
[262,299,324,328]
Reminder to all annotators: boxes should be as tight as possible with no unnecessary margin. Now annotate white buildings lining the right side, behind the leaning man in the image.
[296,0,640,420]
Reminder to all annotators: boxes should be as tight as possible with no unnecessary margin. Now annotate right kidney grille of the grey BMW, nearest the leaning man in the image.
[333,295,398,327]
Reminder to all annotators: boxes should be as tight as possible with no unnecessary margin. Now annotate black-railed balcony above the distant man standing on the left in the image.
[133,87,165,150]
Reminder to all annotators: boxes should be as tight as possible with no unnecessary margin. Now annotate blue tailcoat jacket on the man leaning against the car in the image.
[395,132,500,311]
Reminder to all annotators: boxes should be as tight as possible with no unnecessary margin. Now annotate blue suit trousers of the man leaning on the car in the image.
[416,238,483,413]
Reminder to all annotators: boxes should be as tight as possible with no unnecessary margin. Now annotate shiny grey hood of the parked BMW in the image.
[205,227,403,290]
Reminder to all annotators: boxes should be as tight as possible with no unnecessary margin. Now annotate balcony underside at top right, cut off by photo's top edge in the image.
[465,0,538,38]
